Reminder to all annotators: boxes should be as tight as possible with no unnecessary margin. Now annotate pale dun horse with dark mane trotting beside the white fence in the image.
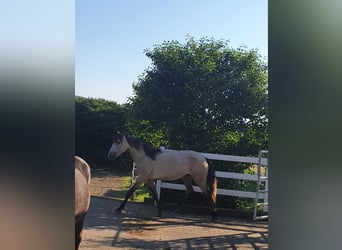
[108,132,217,221]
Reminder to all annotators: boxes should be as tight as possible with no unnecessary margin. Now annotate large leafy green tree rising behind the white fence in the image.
[130,37,268,155]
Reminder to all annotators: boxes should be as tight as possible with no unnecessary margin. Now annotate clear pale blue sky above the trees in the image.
[75,0,268,103]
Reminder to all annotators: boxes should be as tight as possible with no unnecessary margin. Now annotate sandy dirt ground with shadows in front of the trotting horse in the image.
[80,165,268,250]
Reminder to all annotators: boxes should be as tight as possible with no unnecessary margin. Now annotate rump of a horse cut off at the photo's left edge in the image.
[75,156,91,250]
